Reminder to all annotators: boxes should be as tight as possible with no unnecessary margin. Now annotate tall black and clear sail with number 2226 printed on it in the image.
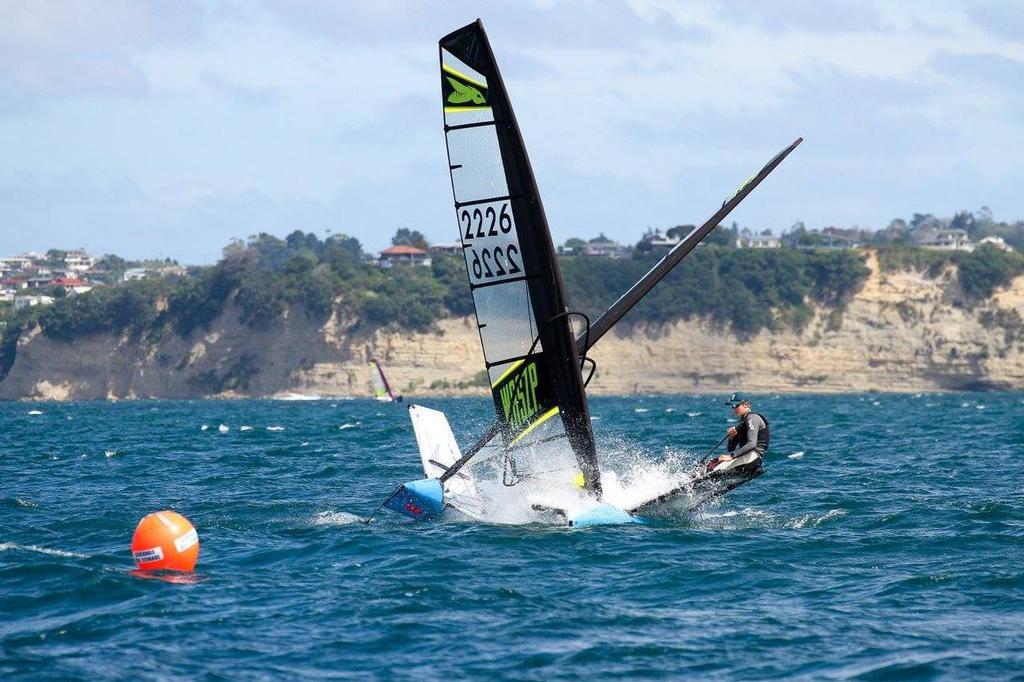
[439,20,601,493]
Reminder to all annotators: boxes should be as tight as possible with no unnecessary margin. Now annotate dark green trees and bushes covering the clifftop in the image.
[0,216,1024,380]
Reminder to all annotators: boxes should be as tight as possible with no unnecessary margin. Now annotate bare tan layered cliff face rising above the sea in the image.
[0,250,1024,399]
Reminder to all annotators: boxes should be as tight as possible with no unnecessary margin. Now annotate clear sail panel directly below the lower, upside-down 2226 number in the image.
[473,282,541,363]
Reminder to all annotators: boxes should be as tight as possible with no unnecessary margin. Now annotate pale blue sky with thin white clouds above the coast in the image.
[0,0,1024,264]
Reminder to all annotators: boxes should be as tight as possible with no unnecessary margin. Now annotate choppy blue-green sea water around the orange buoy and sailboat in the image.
[0,393,1024,680]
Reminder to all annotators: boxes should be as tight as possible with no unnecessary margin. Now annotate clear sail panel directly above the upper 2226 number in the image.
[447,126,509,204]
